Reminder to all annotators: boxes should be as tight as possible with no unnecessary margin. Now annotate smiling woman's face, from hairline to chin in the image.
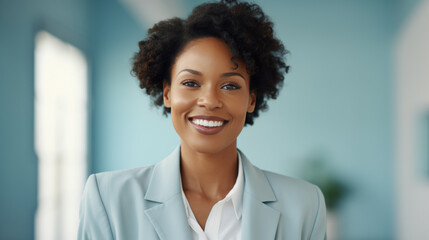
[163,37,256,153]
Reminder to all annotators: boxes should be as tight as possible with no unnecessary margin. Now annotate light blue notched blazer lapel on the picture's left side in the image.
[145,146,191,240]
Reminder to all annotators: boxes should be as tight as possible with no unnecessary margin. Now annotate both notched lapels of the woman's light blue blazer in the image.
[145,146,280,239]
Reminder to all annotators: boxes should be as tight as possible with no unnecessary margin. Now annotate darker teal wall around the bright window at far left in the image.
[0,0,89,237]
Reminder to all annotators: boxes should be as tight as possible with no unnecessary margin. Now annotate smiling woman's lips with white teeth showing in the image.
[189,116,228,135]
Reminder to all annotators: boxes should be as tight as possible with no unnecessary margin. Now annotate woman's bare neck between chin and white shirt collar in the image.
[180,143,238,200]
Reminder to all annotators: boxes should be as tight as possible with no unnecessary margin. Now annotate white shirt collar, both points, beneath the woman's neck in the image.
[180,151,244,219]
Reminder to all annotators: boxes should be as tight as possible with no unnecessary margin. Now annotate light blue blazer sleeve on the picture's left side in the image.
[77,174,113,240]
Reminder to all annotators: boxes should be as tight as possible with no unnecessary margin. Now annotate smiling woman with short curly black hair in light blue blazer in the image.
[78,1,326,240]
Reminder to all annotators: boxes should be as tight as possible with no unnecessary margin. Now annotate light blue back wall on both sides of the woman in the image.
[89,1,395,240]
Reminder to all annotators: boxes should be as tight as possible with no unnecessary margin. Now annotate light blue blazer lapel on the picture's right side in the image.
[240,152,280,240]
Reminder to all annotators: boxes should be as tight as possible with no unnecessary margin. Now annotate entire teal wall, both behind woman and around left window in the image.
[0,0,419,240]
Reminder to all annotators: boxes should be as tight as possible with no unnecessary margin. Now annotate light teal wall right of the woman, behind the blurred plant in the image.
[240,1,395,240]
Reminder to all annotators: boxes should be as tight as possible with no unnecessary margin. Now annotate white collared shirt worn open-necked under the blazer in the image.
[182,153,244,240]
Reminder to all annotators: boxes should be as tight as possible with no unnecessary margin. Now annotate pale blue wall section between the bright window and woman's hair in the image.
[91,1,176,172]
